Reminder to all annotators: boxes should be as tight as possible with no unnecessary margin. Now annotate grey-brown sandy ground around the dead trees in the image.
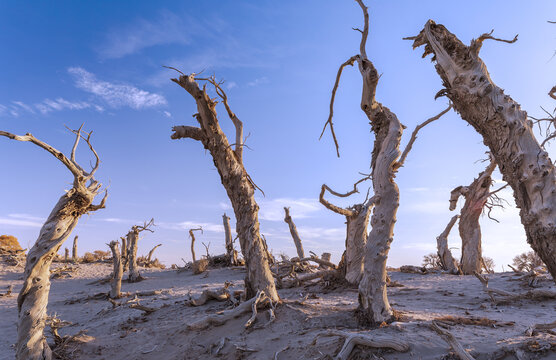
[0,264,556,360]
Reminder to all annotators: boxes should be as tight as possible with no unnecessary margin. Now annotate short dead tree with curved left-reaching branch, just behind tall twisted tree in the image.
[319,178,374,285]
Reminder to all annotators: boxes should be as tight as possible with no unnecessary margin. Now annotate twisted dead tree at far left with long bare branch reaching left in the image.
[0,125,108,360]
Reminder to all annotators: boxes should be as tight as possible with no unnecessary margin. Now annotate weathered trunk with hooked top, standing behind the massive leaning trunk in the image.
[450,161,496,275]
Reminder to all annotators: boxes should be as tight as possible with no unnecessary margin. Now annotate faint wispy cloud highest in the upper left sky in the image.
[96,11,196,59]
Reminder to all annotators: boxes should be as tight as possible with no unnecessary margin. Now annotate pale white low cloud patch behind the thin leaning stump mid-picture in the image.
[257,198,322,221]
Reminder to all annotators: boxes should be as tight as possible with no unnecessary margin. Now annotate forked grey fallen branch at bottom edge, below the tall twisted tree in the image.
[313,330,409,360]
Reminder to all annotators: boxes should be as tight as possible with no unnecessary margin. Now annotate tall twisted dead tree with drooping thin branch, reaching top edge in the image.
[321,0,450,325]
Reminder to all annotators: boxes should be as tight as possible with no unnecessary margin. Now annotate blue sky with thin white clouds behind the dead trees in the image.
[0,0,556,269]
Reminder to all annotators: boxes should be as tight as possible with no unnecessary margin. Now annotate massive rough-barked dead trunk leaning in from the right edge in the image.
[411,20,556,281]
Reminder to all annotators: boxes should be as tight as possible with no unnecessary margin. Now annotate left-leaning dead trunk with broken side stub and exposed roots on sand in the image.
[171,74,279,301]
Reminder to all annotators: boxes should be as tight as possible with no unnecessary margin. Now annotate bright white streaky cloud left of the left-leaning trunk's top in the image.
[68,67,167,109]
